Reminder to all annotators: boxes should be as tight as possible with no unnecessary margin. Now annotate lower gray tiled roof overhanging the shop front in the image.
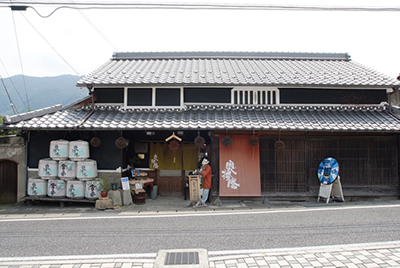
[7,105,400,132]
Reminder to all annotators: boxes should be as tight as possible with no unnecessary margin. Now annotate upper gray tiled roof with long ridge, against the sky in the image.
[78,52,400,88]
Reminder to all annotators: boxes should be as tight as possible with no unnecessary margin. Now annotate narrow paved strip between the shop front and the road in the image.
[0,197,400,216]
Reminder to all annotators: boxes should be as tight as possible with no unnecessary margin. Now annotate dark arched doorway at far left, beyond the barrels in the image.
[0,160,18,204]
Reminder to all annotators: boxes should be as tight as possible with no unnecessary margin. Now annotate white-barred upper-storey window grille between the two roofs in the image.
[232,88,279,105]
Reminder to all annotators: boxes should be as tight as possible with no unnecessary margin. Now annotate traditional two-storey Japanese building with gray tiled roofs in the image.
[0,52,400,203]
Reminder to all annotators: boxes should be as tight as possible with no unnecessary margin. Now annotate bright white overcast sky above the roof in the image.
[0,0,400,78]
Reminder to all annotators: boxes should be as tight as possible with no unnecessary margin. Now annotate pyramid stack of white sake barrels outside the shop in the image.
[28,140,100,200]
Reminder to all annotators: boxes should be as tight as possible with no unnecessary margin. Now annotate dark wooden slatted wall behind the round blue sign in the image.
[260,134,399,196]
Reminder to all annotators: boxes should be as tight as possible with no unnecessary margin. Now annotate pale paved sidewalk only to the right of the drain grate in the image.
[209,241,400,268]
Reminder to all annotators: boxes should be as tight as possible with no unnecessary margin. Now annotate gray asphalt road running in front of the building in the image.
[0,207,400,257]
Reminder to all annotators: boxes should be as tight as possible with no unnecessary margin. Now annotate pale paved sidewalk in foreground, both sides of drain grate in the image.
[0,241,400,268]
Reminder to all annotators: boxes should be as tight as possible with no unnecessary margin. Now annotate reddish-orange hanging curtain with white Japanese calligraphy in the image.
[219,135,261,196]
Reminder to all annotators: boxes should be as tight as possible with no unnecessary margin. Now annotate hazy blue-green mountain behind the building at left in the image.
[0,75,88,115]
